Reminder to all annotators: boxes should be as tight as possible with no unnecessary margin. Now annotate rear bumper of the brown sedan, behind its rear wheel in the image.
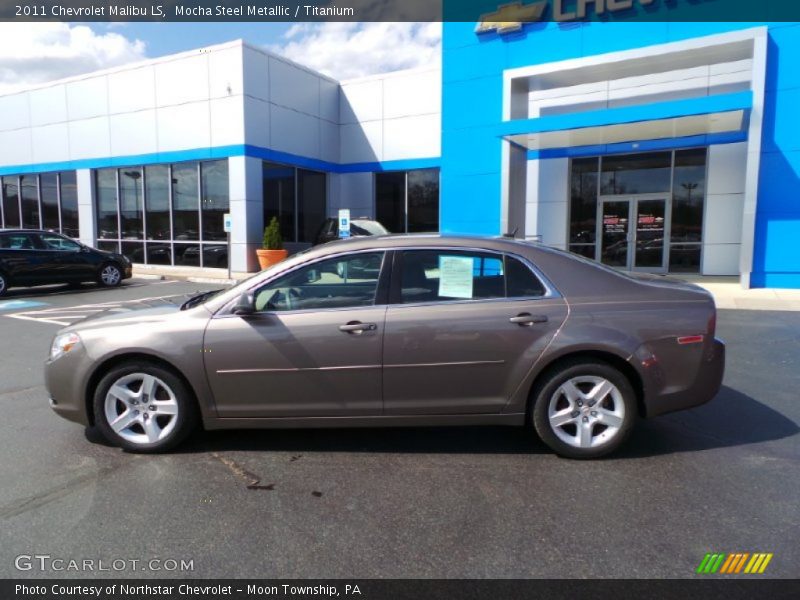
[645,338,725,417]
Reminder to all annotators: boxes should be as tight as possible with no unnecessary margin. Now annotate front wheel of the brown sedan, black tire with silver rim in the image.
[93,361,198,454]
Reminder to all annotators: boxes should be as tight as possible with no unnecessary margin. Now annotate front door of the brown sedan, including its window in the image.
[204,252,388,417]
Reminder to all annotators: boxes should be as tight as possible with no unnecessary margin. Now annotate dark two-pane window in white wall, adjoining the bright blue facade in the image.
[375,169,439,233]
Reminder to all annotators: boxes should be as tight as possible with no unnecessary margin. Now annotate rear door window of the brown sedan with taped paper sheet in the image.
[400,250,505,304]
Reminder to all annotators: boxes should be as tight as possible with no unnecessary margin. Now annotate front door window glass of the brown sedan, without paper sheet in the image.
[255,252,384,312]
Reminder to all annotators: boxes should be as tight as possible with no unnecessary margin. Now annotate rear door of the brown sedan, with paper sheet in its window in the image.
[383,249,567,415]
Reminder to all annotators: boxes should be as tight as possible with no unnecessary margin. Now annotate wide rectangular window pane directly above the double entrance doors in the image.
[600,152,672,196]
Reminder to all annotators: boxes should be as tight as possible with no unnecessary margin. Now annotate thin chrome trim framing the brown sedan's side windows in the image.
[212,245,563,318]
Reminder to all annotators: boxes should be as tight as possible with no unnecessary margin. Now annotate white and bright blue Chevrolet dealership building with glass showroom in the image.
[0,19,800,288]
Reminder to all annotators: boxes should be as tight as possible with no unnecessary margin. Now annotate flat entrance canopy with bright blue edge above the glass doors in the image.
[501,92,753,150]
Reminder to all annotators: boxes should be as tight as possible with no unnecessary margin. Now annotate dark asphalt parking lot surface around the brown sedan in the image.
[0,279,800,578]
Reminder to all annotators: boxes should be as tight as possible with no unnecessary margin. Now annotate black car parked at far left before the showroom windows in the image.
[0,229,131,296]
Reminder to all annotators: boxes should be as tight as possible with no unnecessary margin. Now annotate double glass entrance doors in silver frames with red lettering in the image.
[598,197,667,273]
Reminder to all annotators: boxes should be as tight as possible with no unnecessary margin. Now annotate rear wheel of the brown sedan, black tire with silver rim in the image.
[531,360,637,459]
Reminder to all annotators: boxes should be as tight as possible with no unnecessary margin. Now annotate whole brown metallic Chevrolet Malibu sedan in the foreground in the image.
[45,235,725,458]
